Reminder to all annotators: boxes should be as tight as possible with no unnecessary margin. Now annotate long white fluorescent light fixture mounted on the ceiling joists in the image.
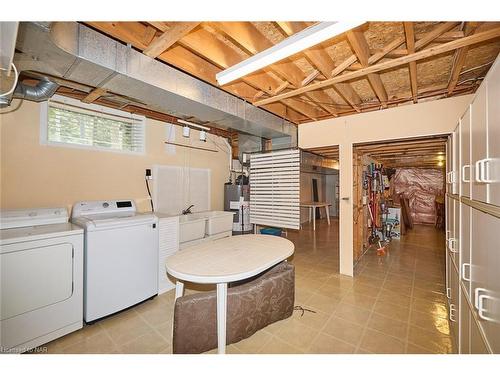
[215,21,364,85]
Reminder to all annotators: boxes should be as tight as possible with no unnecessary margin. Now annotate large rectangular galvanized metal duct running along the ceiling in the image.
[14,22,297,146]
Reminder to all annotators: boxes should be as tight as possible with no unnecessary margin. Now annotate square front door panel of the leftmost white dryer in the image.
[0,241,73,321]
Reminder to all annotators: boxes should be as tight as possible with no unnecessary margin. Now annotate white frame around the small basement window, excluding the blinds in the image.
[40,95,147,155]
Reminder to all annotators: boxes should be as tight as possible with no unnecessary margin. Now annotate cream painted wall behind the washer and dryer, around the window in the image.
[0,100,229,211]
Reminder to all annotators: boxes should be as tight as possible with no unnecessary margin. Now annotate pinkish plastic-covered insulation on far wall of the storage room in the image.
[391,168,444,224]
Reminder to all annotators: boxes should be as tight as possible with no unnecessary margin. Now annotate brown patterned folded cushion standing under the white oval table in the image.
[173,262,295,354]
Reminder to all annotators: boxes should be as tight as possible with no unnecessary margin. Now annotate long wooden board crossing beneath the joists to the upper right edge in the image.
[253,27,500,106]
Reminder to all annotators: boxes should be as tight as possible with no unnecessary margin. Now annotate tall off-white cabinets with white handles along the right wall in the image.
[446,55,500,354]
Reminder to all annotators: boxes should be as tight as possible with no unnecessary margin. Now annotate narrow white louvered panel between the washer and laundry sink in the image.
[158,216,179,294]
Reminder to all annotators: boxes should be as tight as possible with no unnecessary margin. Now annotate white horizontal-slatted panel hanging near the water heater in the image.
[250,150,300,229]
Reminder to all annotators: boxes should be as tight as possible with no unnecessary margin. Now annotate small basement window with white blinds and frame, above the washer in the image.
[40,96,145,154]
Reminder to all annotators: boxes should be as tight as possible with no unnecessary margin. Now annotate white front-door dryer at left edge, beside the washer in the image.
[0,208,83,353]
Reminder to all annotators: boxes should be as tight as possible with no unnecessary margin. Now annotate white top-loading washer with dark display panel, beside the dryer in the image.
[71,200,158,323]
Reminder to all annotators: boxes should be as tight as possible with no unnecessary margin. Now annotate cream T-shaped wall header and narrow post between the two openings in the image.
[299,95,473,275]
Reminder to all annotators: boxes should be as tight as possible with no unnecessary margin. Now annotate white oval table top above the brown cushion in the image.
[165,234,295,284]
